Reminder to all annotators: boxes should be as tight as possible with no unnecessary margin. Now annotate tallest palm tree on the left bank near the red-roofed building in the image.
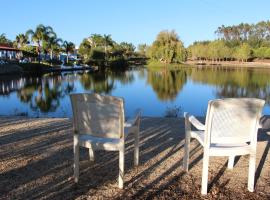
[26,24,56,62]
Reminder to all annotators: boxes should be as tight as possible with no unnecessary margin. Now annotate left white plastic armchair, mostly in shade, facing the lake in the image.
[70,94,140,188]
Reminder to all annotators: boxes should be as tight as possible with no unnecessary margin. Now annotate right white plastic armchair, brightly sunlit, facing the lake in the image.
[183,98,265,195]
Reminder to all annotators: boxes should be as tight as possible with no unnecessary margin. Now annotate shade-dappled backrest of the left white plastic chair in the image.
[70,93,124,138]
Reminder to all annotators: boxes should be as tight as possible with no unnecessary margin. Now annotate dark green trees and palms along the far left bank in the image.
[0,24,145,69]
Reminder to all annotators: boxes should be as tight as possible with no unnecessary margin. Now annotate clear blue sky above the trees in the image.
[0,0,270,46]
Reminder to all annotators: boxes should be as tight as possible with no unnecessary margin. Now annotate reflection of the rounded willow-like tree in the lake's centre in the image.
[147,69,187,101]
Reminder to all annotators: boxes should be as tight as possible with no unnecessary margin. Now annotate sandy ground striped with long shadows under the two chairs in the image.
[0,117,270,199]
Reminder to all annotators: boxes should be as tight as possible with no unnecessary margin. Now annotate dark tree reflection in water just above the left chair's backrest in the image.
[80,72,114,94]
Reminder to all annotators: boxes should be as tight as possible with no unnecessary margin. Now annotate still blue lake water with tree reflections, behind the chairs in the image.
[0,67,270,117]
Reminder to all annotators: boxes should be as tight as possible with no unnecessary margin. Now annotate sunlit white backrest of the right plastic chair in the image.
[204,98,265,145]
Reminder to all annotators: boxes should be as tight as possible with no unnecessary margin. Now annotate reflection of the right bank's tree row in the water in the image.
[191,69,270,104]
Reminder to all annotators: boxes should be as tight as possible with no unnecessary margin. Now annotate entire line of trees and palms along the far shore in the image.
[0,21,270,67]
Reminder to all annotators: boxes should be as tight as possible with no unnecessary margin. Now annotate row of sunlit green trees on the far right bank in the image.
[188,21,270,61]
